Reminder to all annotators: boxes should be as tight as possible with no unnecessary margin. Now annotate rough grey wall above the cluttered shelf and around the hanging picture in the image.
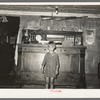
[20,16,100,74]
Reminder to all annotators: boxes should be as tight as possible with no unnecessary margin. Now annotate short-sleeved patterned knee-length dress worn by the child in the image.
[42,52,60,78]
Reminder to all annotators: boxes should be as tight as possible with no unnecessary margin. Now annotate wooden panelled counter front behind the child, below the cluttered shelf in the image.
[17,44,86,88]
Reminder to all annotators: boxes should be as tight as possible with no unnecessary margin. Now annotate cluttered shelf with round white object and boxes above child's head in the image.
[22,29,83,47]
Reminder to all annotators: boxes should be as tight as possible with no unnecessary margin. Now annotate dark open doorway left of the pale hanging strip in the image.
[0,16,20,83]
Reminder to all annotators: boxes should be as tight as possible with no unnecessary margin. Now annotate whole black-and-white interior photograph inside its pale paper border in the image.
[0,3,100,89]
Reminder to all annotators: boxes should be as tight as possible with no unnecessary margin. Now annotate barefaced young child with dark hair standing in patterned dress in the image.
[41,41,60,88]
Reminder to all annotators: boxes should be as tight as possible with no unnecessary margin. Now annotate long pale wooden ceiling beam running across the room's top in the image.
[0,10,100,18]
